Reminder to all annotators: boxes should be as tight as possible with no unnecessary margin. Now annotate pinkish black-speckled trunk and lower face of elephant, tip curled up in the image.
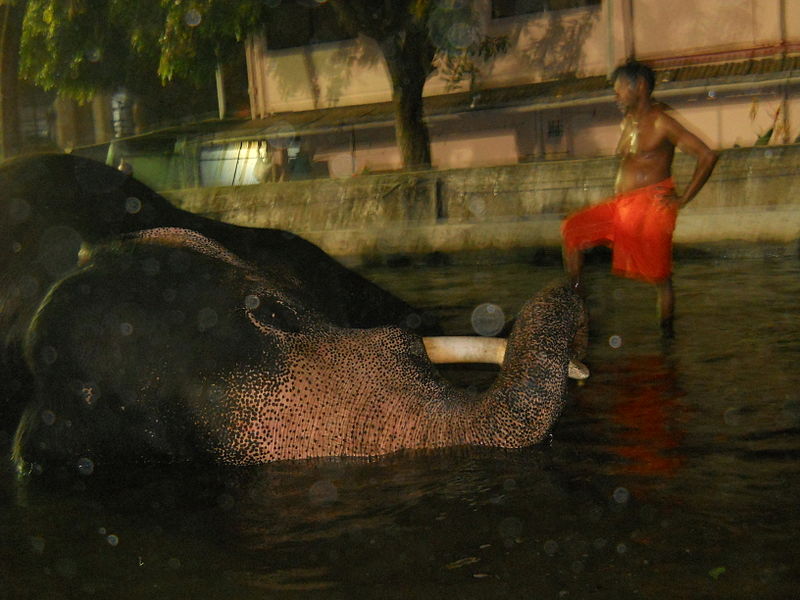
[195,288,583,464]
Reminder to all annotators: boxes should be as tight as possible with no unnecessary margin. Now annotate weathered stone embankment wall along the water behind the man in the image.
[164,144,800,264]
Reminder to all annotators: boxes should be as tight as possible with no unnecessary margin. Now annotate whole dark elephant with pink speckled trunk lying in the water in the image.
[0,155,587,473]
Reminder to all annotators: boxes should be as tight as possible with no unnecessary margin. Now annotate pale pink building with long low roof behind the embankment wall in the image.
[51,0,800,189]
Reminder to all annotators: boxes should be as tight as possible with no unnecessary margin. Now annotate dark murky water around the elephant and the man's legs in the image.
[0,259,800,599]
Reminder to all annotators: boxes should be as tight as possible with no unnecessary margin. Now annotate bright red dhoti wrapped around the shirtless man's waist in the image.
[561,177,678,283]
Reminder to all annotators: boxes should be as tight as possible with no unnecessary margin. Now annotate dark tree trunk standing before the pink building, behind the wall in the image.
[380,31,432,169]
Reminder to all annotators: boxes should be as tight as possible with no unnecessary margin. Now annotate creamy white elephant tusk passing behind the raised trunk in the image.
[422,336,589,379]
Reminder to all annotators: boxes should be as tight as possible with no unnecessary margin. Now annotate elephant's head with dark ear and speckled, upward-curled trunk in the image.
[14,230,585,472]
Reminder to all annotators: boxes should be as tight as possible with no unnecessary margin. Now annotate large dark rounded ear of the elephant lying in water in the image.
[17,239,282,468]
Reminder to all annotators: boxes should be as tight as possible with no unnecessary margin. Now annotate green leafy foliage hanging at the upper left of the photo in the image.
[20,0,263,100]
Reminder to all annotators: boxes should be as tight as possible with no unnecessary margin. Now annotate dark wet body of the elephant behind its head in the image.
[0,154,438,438]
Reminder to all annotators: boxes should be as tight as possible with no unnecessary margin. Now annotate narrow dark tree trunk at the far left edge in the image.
[0,2,25,160]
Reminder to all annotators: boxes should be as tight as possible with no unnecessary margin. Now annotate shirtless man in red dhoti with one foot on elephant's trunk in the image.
[561,61,717,335]
